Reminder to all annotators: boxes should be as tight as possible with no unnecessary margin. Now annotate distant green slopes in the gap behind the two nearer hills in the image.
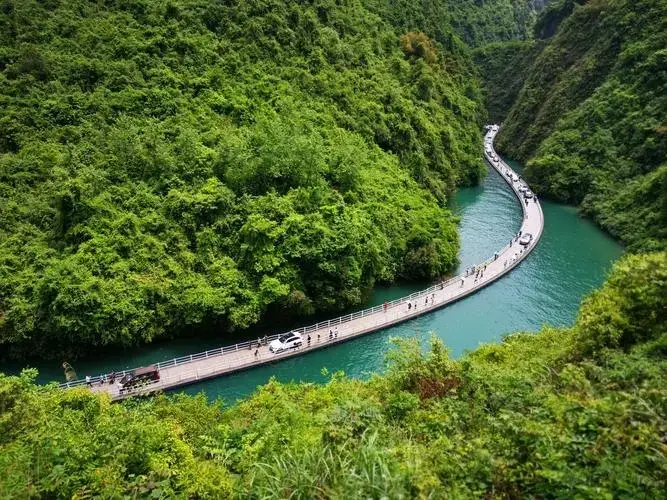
[366,0,556,122]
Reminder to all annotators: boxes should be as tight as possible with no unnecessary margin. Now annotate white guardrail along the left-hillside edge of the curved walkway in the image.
[60,125,543,392]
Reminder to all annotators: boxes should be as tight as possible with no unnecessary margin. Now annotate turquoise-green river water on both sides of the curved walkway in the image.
[13,162,622,403]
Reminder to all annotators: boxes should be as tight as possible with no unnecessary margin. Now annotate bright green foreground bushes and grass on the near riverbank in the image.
[0,253,667,498]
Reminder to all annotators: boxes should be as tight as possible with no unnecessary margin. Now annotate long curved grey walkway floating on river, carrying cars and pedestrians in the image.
[61,127,544,400]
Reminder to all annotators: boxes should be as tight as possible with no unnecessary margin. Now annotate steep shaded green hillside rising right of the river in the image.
[498,0,667,250]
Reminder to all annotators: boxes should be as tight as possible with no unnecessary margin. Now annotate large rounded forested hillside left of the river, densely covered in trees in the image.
[0,0,484,356]
